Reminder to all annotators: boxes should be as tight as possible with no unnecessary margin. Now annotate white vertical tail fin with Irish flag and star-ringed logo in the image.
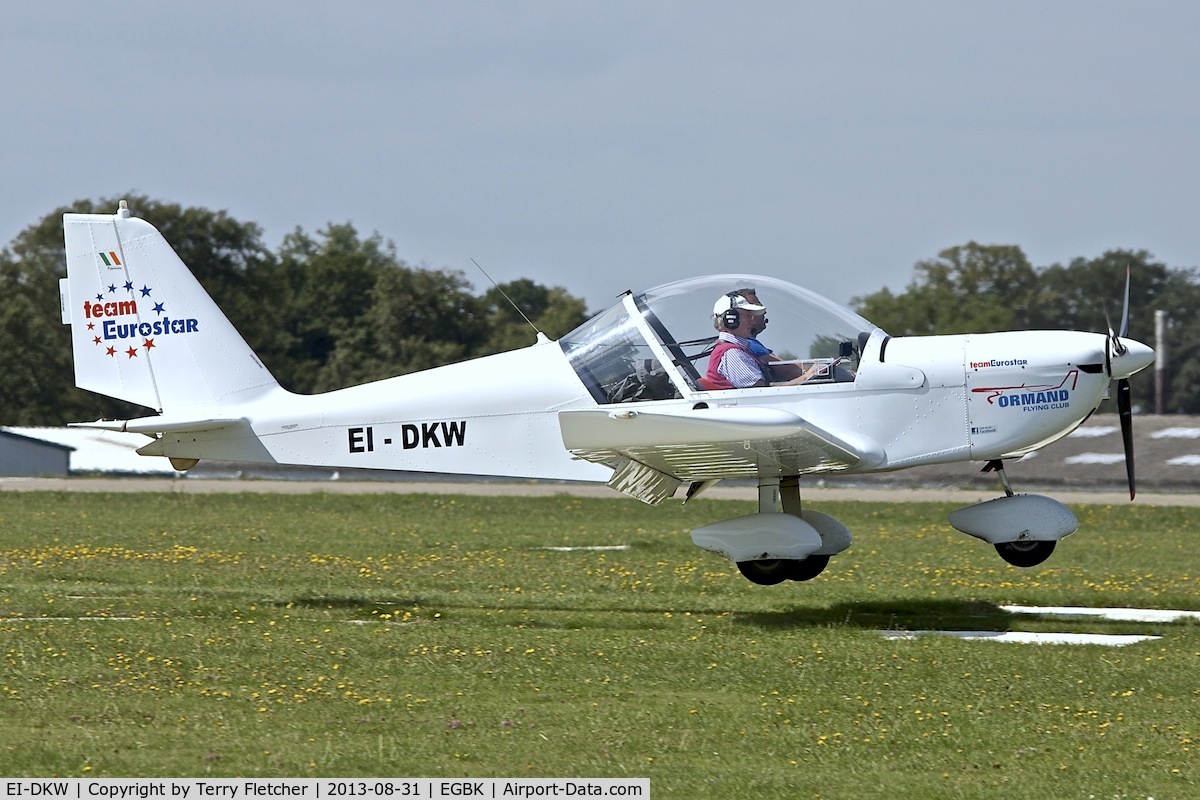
[59,200,278,415]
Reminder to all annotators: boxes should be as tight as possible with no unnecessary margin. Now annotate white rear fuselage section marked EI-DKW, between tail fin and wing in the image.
[142,335,608,481]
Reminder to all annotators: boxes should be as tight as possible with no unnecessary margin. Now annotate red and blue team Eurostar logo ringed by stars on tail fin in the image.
[83,280,200,360]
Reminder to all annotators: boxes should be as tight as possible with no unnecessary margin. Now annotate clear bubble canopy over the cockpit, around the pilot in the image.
[559,273,876,403]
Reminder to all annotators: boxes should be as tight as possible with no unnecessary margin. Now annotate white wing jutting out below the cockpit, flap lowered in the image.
[558,408,884,504]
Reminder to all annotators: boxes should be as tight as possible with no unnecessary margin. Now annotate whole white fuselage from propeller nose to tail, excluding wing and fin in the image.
[144,331,1128,481]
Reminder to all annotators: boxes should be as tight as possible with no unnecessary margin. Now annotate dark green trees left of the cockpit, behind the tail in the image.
[0,196,587,426]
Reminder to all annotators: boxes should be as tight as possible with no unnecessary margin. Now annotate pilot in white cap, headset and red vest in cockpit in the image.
[704,291,816,389]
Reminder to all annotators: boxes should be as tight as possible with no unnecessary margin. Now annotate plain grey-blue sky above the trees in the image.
[0,0,1200,309]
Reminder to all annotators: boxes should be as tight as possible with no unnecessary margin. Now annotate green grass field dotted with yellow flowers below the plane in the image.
[0,492,1200,800]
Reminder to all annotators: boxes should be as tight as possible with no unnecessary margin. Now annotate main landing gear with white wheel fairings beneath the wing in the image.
[691,477,852,587]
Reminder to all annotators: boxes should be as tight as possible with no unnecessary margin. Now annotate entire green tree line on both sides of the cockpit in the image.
[0,197,1200,426]
